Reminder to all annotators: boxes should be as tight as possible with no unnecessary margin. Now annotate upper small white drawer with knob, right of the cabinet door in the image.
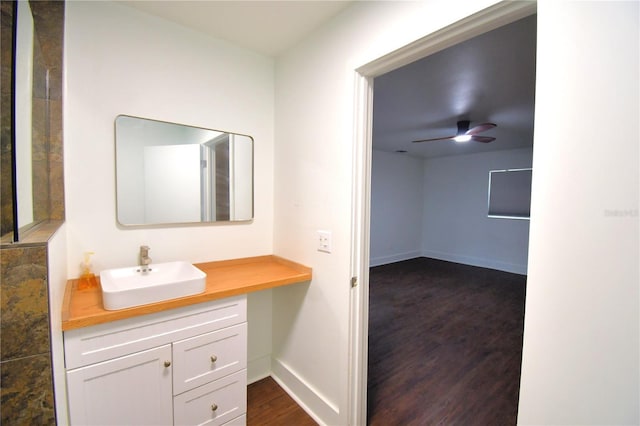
[173,322,247,395]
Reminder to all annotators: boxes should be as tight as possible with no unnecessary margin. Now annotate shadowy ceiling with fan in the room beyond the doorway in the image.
[373,15,536,157]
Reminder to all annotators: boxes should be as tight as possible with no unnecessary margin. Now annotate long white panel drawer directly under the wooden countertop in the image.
[64,295,247,369]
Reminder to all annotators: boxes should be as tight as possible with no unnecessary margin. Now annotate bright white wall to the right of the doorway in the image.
[518,1,640,425]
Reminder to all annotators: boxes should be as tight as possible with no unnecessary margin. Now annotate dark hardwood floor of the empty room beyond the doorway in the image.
[368,258,526,426]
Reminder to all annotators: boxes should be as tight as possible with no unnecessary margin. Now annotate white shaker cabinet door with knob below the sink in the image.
[67,345,173,426]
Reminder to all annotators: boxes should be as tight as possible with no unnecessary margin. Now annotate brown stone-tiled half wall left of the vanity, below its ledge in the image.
[0,245,55,425]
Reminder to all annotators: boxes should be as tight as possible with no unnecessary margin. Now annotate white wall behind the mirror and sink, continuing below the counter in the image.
[64,1,274,392]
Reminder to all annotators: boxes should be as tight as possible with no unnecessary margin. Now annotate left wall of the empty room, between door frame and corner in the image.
[370,150,424,266]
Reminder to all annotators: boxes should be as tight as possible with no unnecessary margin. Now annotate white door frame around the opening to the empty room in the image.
[347,1,537,425]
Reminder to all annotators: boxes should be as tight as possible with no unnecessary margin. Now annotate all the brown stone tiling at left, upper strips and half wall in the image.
[0,0,64,425]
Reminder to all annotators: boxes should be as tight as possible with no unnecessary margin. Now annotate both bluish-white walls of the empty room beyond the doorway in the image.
[370,148,532,274]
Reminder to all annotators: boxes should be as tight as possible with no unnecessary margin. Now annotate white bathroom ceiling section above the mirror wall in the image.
[119,0,353,56]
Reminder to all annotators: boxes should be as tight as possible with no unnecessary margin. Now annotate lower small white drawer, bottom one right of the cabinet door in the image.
[173,370,247,426]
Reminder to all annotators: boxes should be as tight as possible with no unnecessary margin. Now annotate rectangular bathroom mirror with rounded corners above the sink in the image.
[115,115,253,226]
